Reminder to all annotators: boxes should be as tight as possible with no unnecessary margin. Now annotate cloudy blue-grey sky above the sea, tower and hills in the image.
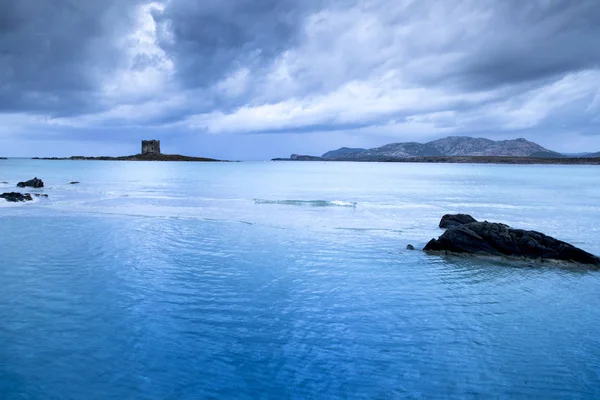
[0,0,600,159]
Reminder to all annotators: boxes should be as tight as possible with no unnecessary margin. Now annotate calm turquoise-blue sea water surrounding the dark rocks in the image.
[0,160,600,399]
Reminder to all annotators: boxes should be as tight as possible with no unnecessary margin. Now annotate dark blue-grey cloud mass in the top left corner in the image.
[0,0,142,115]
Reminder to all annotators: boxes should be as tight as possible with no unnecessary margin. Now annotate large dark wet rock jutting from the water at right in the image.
[423,214,600,267]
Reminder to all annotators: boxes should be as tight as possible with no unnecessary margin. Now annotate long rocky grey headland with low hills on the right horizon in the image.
[273,136,600,165]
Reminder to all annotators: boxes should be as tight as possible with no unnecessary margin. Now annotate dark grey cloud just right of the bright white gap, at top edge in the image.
[154,0,322,87]
